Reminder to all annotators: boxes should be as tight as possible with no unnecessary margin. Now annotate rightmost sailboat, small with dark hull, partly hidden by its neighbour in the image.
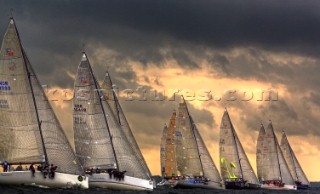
[280,131,310,190]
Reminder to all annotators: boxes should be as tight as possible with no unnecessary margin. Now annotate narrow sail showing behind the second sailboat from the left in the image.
[101,72,151,178]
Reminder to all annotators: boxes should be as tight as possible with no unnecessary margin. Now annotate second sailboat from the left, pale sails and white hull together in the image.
[73,53,154,190]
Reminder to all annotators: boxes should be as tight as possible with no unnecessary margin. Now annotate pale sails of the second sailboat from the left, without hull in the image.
[74,53,149,179]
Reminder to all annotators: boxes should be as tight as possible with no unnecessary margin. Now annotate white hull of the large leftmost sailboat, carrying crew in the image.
[0,171,89,189]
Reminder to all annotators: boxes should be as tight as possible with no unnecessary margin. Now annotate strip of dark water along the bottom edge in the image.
[0,184,320,194]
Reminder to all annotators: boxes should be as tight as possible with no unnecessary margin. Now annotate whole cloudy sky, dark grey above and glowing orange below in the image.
[0,0,320,181]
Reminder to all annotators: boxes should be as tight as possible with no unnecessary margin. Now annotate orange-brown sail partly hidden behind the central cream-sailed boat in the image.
[162,111,180,176]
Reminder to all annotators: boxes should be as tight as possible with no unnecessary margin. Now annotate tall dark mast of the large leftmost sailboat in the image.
[10,17,49,162]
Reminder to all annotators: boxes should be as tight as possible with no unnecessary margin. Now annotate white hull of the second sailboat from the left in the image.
[88,173,154,191]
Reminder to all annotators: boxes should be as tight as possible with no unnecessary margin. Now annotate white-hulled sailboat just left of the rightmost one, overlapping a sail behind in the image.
[257,121,297,190]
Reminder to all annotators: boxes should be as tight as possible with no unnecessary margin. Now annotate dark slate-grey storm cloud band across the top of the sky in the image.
[0,0,320,69]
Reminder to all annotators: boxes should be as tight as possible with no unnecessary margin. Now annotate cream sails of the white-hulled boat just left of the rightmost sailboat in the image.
[258,122,295,185]
